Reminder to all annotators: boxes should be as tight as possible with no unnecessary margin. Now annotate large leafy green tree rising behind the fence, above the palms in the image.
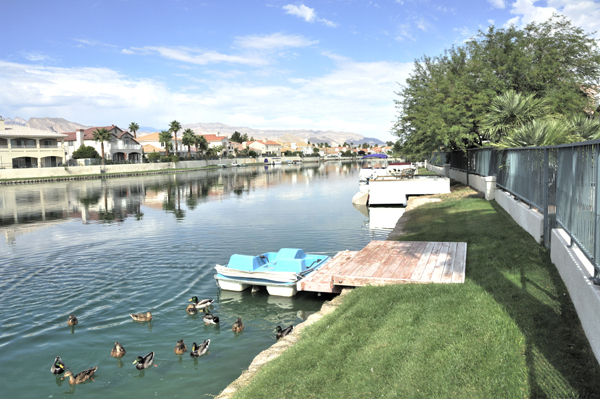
[393,15,600,156]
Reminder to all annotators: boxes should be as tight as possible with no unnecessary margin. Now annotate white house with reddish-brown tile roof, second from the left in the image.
[64,125,142,162]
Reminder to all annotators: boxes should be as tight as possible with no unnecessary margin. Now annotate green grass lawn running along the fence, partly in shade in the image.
[235,185,600,399]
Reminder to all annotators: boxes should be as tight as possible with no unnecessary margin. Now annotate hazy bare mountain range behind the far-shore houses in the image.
[5,117,385,146]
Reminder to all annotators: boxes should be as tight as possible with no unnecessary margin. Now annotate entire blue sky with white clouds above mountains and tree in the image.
[0,0,600,141]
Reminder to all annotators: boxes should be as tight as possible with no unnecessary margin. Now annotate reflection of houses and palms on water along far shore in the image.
[0,163,359,243]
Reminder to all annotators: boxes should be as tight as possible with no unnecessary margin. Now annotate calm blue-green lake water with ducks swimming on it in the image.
[0,164,398,398]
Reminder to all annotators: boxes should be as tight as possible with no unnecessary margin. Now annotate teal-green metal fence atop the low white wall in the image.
[430,140,600,277]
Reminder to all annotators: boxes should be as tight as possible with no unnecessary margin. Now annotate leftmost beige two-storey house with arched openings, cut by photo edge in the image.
[0,117,65,169]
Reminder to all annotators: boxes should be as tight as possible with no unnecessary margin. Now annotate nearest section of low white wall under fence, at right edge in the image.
[550,229,600,361]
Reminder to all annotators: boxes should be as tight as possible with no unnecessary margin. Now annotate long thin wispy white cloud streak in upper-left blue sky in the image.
[121,46,269,66]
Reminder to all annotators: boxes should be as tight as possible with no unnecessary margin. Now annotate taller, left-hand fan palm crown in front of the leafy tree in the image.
[481,90,552,142]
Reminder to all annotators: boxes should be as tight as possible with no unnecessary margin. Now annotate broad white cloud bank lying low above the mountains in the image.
[0,54,413,139]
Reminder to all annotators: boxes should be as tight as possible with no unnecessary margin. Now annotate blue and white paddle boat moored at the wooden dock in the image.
[215,248,329,297]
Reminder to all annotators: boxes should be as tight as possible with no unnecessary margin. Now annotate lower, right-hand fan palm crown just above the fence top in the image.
[494,119,571,149]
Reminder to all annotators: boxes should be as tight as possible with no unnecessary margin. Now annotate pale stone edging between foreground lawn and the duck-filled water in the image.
[216,288,351,399]
